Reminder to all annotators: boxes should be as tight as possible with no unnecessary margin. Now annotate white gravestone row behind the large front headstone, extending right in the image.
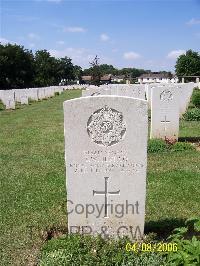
[82,83,195,141]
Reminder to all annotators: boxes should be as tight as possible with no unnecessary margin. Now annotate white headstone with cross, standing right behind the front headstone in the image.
[150,86,179,141]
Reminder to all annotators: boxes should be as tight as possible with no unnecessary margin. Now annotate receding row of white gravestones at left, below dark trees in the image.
[0,85,85,109]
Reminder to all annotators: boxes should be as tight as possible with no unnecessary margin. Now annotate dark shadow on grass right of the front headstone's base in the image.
[144,218,186,240]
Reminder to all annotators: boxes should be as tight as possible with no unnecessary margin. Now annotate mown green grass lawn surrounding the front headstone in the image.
[0,90,200,265]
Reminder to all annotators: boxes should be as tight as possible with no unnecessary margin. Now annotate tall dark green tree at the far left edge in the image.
[0,44,35,89]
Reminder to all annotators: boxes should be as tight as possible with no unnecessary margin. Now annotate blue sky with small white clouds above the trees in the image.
[0,0,200,72]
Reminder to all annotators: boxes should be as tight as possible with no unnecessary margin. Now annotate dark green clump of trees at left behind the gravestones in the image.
[0,44,82,89]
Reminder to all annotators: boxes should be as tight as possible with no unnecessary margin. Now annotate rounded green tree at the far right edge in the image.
[175,50,200,77]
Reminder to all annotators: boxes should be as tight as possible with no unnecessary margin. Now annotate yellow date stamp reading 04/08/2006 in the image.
[125,242,178,253]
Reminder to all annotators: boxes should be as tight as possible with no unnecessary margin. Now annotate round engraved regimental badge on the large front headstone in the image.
[87,106,126,147]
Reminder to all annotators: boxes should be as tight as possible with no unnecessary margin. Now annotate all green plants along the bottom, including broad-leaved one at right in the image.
[39,218,200,266]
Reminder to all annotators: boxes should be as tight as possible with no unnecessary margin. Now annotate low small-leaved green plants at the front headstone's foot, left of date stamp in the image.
[39,235,165,266]
